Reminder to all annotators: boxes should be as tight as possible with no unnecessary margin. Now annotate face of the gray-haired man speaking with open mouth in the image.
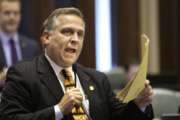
[46,15,85,67]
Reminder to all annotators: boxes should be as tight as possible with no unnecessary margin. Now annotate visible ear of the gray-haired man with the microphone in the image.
[40,32,51,48]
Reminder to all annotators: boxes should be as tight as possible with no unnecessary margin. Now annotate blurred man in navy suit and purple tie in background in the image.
[0,0,38,89]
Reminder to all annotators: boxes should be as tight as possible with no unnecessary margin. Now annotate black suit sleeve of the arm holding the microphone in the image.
[0,68,55,120]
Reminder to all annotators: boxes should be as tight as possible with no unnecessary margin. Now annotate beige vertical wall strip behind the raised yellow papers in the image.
[140,0,160,74]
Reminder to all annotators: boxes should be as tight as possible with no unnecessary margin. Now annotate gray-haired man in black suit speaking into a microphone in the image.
[0,8,153,120]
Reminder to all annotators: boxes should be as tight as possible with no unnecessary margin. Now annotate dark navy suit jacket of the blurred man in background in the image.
[0,35,40,69]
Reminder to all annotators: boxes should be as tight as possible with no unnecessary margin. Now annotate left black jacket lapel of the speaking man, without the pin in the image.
[38,55,64,101]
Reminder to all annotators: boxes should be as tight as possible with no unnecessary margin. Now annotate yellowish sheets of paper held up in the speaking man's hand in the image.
[117,34,149,103]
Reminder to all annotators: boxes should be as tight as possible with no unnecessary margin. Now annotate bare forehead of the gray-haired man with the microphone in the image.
[56,15,85,30]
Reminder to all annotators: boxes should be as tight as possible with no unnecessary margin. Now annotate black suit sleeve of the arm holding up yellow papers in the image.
[103,73,153,120]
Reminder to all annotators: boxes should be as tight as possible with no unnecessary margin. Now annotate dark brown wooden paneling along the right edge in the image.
[159,0,180,88]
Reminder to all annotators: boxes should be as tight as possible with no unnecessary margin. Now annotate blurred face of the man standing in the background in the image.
[0,1,21,34]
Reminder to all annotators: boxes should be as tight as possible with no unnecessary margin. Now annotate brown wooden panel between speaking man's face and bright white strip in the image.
[76,0,96,68]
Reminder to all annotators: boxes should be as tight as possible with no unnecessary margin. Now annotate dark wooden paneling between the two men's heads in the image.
[25,0,55,40]
